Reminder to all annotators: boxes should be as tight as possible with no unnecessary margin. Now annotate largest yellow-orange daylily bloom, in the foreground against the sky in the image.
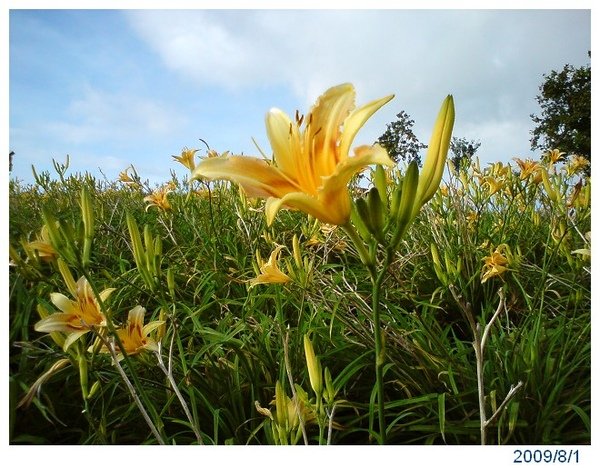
[193,84,393,225]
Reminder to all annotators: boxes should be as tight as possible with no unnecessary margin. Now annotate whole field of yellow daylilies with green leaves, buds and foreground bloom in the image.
[9,85,591,445]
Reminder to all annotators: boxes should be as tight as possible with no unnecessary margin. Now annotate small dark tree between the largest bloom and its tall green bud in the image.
[377,111,427,165]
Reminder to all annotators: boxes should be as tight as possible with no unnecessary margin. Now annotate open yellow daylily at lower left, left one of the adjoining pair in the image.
[34,277,114,350]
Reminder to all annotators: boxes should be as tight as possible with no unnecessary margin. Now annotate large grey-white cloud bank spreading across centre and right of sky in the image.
[127,10,590,168]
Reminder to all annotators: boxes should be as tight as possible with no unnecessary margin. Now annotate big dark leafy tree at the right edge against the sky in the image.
[531,52,592,166]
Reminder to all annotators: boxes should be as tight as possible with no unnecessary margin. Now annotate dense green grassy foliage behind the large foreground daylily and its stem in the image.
[9,148,591,444]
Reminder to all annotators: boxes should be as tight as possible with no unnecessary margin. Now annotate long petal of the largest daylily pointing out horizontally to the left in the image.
[192,156,299,198]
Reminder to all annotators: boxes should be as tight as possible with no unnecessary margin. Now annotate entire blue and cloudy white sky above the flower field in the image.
[9,10,591,183]
